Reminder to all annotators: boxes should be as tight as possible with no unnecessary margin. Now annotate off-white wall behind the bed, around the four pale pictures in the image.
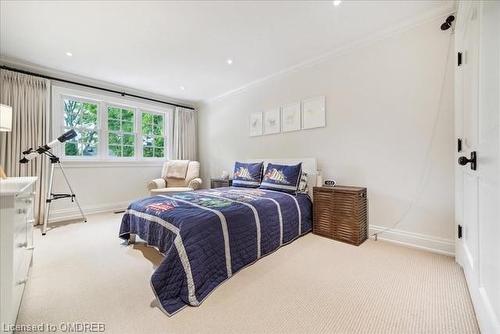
[199,19,455,253]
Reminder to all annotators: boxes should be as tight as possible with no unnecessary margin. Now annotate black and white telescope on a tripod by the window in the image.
[19,130,87,235]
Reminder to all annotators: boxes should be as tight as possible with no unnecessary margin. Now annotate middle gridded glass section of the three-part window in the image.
[108,107,135,158]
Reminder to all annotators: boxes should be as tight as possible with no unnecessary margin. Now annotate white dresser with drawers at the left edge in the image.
[0,177,37,330]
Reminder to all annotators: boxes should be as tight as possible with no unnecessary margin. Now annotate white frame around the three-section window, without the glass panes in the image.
[52,85,174,166]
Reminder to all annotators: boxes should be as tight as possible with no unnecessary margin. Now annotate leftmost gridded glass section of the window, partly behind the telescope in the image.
[64,98,99,156]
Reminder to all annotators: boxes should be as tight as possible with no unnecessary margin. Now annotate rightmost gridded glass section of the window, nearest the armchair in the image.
[141,112,165,158]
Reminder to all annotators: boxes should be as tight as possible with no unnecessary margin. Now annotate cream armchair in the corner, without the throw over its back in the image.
[148,161,202,195]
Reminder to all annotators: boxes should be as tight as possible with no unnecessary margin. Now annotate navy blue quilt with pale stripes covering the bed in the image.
[120,187,312,315]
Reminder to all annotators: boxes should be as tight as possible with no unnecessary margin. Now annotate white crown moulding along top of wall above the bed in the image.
[203,7,456,103]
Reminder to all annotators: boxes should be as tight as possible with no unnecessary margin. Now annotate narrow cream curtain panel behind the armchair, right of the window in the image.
[172,107,198,161]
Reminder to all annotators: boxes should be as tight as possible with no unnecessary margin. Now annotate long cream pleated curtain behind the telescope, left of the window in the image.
[0,70,50,224]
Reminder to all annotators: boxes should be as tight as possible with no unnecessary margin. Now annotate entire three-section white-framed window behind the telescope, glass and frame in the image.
[57,87,173,161]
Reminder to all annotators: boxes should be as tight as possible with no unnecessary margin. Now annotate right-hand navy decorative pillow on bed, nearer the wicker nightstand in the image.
[260,163,302,194]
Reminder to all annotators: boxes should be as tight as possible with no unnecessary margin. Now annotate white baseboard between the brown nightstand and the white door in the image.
[370,225,455,256]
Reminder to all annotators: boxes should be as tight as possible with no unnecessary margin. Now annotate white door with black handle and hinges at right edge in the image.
[455,1,500,333]
